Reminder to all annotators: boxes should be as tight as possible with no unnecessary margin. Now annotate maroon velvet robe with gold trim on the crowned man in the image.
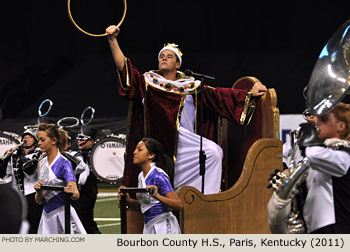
[118,59,248,187]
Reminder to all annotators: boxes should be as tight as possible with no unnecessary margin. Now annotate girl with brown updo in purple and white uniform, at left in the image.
[34,123,86,234]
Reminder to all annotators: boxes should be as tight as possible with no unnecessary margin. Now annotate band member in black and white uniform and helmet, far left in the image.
[0,128,42,234]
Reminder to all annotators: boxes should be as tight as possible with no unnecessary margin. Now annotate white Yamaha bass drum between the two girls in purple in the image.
[90,136,125,184]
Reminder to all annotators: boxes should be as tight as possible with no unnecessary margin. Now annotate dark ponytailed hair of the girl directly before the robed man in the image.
[141,138,174,184]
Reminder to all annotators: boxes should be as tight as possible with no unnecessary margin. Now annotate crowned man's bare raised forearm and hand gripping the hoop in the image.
[106,25,125,71]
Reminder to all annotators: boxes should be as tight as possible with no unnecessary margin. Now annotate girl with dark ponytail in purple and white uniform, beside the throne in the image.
[119,138,183,234]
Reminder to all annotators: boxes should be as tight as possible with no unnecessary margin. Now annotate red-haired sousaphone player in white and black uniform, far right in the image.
[268,103,350,234]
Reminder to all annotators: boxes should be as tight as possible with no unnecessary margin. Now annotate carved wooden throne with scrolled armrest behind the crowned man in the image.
[177,77,282,233]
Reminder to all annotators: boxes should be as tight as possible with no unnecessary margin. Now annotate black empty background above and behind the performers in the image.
[0,0,350,120]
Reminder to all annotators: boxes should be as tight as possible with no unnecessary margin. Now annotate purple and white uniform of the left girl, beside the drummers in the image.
[38,152,86,234]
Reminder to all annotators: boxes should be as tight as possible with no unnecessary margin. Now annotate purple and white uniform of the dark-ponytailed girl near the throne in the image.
[136,163,181,234]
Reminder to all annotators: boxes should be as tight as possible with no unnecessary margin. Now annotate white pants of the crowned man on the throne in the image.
[174,127,223,194]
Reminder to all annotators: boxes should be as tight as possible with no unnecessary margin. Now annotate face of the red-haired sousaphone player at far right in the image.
[316,113,345,140]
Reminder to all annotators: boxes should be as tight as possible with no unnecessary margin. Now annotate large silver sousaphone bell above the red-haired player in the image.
[305,20,350,116]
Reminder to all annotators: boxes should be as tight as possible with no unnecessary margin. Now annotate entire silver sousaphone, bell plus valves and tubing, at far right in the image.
[268,20,350,233]
